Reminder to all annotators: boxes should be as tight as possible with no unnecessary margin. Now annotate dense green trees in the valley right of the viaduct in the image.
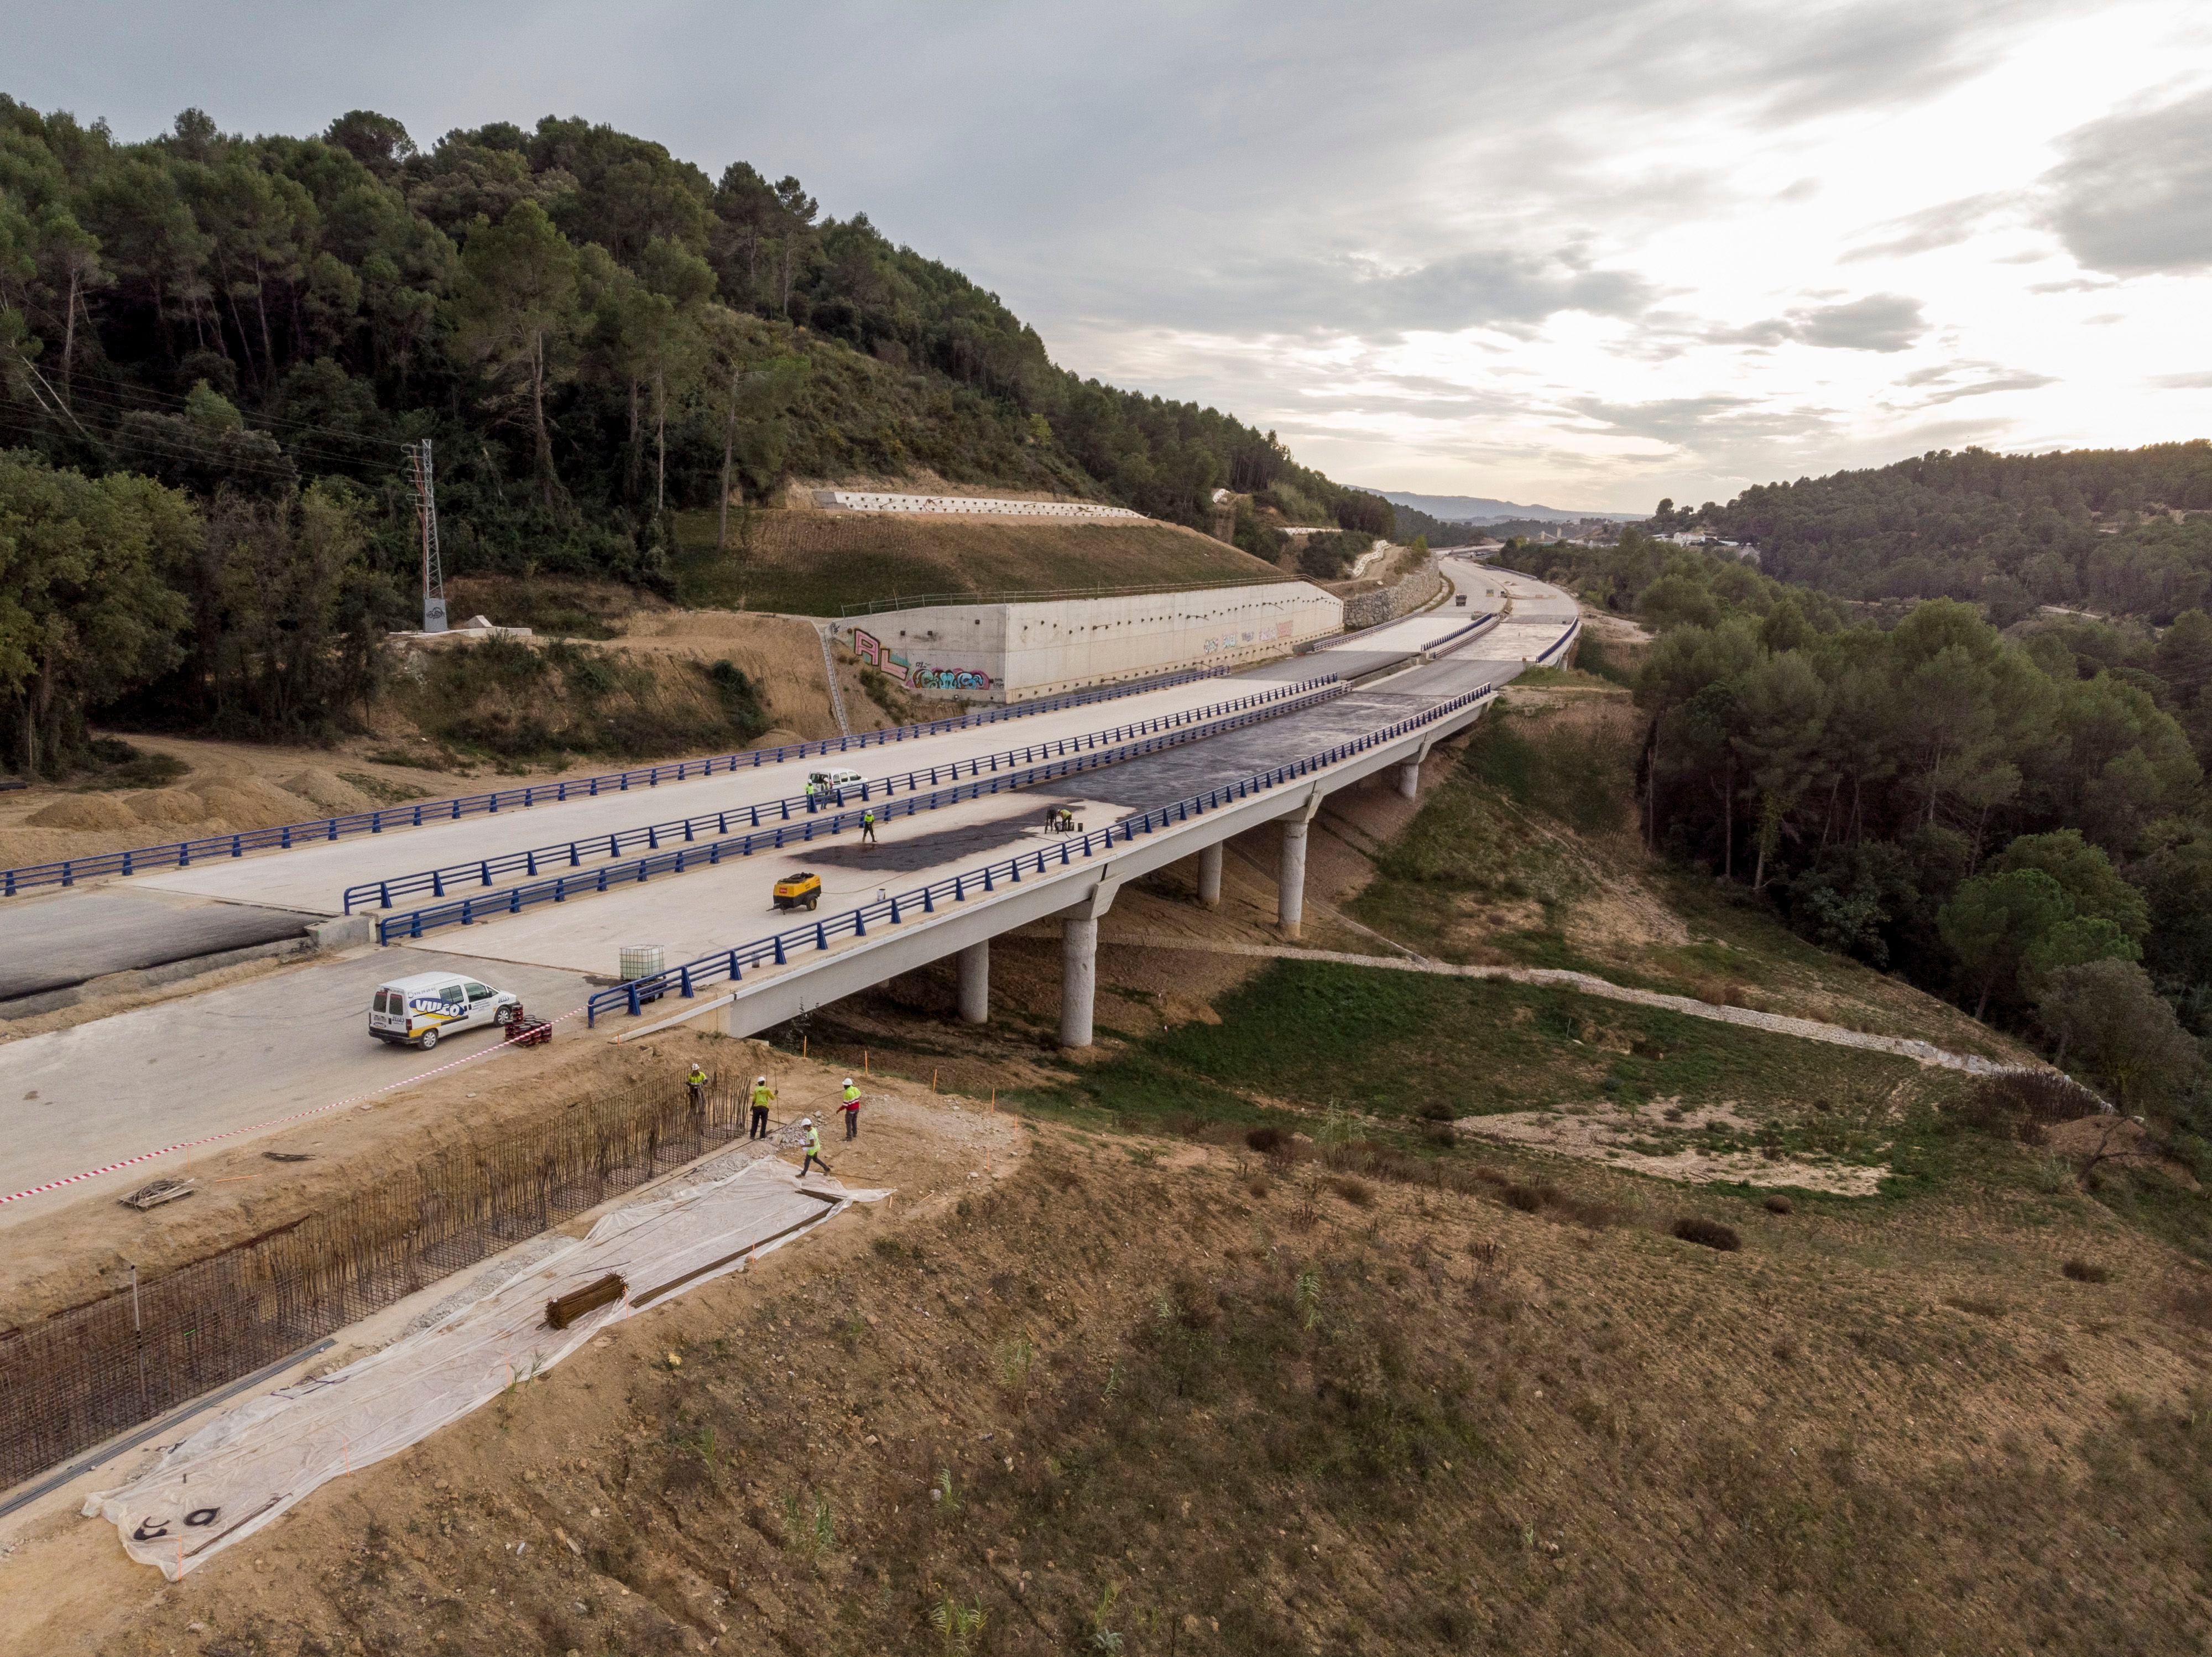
[1502,527,2212,1177]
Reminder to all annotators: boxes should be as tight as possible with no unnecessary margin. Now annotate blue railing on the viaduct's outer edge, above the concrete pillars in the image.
[586,686,1491,1024]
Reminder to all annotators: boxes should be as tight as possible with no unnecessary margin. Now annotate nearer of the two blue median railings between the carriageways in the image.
[376,677,1352,945]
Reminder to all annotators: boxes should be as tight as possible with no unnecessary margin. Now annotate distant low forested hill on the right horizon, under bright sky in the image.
[1650,438,2212,626]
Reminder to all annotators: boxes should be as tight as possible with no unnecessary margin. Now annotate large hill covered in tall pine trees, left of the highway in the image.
[0,97,1394,770]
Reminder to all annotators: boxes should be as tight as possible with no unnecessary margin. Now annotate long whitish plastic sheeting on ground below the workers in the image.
[84,1161,885,1582]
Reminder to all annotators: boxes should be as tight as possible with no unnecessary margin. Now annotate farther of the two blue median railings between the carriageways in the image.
[345,675,1336,914]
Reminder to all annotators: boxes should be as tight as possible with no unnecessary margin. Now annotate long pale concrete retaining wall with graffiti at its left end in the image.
[838,582,1345,701]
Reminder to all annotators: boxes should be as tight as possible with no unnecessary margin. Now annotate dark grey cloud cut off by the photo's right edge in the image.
[2042,88,2212,277]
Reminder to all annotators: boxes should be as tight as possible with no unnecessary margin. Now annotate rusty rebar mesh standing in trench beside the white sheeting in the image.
[0,1066,750,1491]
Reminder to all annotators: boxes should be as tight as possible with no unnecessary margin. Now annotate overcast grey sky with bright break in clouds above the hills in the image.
[0,0,2212,511]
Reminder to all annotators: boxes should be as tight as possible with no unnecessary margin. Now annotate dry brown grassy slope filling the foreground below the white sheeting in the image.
[30,1128,2212,1657]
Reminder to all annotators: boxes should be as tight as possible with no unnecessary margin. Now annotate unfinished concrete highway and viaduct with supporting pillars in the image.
[0,560,1577,1228]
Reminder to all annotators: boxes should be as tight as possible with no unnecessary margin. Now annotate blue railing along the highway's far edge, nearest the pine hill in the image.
[0,666,1230,898]
